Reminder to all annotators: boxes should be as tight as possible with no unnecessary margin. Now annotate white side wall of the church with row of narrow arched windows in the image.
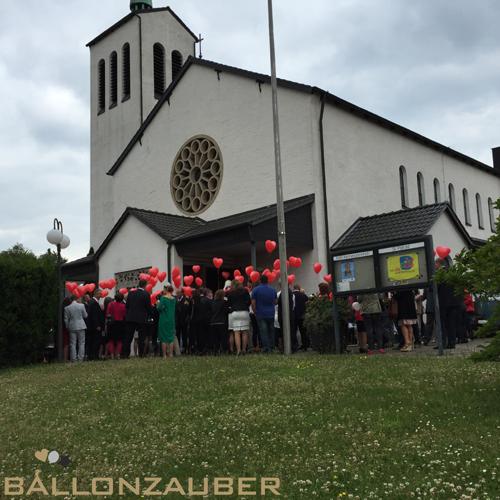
[324,106,500,241]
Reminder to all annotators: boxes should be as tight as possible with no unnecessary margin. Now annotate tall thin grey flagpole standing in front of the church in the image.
[267,0,292,355]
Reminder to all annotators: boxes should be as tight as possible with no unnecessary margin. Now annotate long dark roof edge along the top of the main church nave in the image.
[107,56,500,177]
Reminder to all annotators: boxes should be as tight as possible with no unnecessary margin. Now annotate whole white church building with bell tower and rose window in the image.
[64,0,500,292]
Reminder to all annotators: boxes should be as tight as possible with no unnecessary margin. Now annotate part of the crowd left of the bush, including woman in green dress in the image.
[64,276,312,361]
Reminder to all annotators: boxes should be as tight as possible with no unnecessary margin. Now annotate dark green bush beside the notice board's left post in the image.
[304,296,349,353]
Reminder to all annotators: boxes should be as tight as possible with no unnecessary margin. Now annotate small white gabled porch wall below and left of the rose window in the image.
[98,216,167,290]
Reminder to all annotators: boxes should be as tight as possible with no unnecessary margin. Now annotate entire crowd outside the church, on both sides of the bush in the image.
[64,260,474,361]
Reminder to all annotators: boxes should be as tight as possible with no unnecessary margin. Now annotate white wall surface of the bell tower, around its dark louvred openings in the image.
[90,11,194,249]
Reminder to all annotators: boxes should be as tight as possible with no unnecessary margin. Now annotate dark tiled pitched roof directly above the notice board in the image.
[331,203,473,250]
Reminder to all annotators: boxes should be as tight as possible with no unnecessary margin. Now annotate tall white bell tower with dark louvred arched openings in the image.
[87,0,197,248]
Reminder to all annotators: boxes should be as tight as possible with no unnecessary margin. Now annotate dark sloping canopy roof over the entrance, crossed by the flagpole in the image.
[173,194,314,243]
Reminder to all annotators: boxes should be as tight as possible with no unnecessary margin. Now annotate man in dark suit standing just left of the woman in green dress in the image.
[122,280,151,358]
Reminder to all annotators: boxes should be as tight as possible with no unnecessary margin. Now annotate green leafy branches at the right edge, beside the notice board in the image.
[436,199,500,361]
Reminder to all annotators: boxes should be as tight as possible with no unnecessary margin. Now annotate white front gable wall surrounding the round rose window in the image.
[113,66,318,240]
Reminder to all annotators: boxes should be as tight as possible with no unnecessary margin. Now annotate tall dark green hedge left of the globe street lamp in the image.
[0,245,58,367]
